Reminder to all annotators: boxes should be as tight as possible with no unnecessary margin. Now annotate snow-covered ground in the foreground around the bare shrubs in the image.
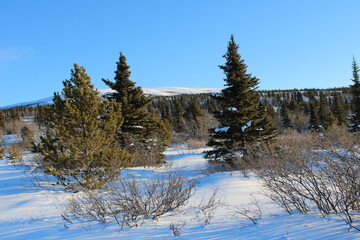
[0,143,360,240]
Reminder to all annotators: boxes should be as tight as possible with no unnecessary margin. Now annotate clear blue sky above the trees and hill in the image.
[0,0,360,106]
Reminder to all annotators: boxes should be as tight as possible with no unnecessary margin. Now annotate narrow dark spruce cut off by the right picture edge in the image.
[350,58,360,131]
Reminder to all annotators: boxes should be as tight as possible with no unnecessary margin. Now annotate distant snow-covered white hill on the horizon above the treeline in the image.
[1,87,221,108]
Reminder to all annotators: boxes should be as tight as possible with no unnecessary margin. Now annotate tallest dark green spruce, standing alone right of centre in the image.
[205,36,276,164]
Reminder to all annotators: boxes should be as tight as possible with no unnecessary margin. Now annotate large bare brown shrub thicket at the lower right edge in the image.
[261,128,360,230]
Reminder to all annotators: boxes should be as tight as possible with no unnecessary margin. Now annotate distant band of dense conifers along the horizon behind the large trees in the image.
[0,84,354,141]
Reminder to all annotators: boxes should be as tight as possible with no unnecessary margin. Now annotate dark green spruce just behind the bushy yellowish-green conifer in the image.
[103,53,169,163]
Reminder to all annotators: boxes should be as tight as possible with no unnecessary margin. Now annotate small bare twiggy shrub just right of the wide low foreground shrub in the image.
[197,188,224,225]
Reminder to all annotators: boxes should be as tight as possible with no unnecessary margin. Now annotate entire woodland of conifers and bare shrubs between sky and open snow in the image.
[0,36,360,232]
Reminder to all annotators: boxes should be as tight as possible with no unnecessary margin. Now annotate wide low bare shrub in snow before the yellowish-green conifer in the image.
[63,172,196,229]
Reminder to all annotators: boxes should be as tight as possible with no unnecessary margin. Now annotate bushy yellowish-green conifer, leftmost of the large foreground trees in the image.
[34,64,132,189]
